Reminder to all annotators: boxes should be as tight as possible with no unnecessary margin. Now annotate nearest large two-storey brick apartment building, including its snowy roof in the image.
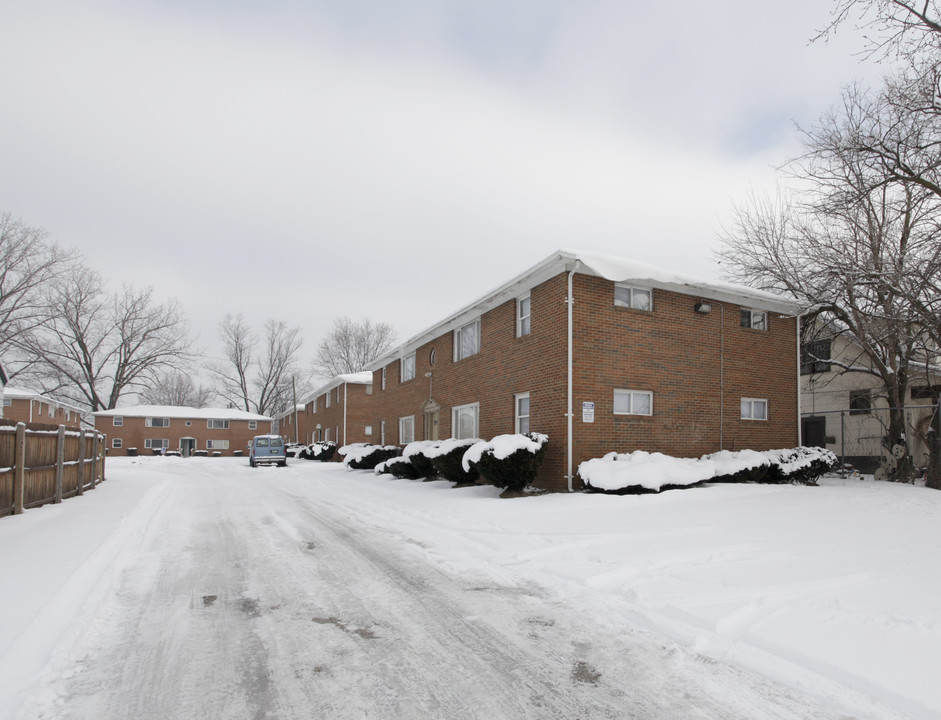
[366,251,800,489]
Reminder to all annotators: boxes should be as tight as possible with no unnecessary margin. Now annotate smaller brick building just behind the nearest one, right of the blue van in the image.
[278,372,376,445]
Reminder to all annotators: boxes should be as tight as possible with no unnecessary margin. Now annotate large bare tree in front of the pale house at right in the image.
[719,89,941,484]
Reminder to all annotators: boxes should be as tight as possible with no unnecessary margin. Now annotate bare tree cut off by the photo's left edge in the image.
[0,213,76,352]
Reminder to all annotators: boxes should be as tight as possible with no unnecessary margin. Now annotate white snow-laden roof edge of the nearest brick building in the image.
[366,248,805,370]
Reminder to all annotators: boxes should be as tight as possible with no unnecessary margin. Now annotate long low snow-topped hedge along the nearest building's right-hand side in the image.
[578,447,838,493]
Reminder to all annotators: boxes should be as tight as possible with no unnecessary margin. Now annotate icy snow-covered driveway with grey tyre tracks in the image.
[0,458,932,720]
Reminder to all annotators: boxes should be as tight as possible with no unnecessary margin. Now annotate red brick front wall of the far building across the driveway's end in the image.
[95,416,271,455]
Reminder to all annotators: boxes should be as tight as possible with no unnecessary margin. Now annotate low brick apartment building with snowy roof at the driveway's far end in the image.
[94,405,271,456]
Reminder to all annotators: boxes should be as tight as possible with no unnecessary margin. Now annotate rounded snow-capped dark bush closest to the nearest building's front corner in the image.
[462,433,549,492]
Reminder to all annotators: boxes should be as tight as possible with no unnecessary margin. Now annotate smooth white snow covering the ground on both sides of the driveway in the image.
[0,458,941,720]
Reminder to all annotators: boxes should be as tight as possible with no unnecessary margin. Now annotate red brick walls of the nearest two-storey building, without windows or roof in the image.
[372,273,798,489]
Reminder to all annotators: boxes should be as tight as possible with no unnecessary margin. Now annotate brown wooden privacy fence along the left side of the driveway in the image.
[0,420,105,517]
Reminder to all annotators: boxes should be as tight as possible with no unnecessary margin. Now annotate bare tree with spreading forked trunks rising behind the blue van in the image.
[208,314,306,415]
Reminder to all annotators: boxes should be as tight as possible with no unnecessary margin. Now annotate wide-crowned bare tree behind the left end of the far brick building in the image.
[14,266,190,412]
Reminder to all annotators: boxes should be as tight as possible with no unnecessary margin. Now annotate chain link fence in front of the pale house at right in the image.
[801,405,941,476]
